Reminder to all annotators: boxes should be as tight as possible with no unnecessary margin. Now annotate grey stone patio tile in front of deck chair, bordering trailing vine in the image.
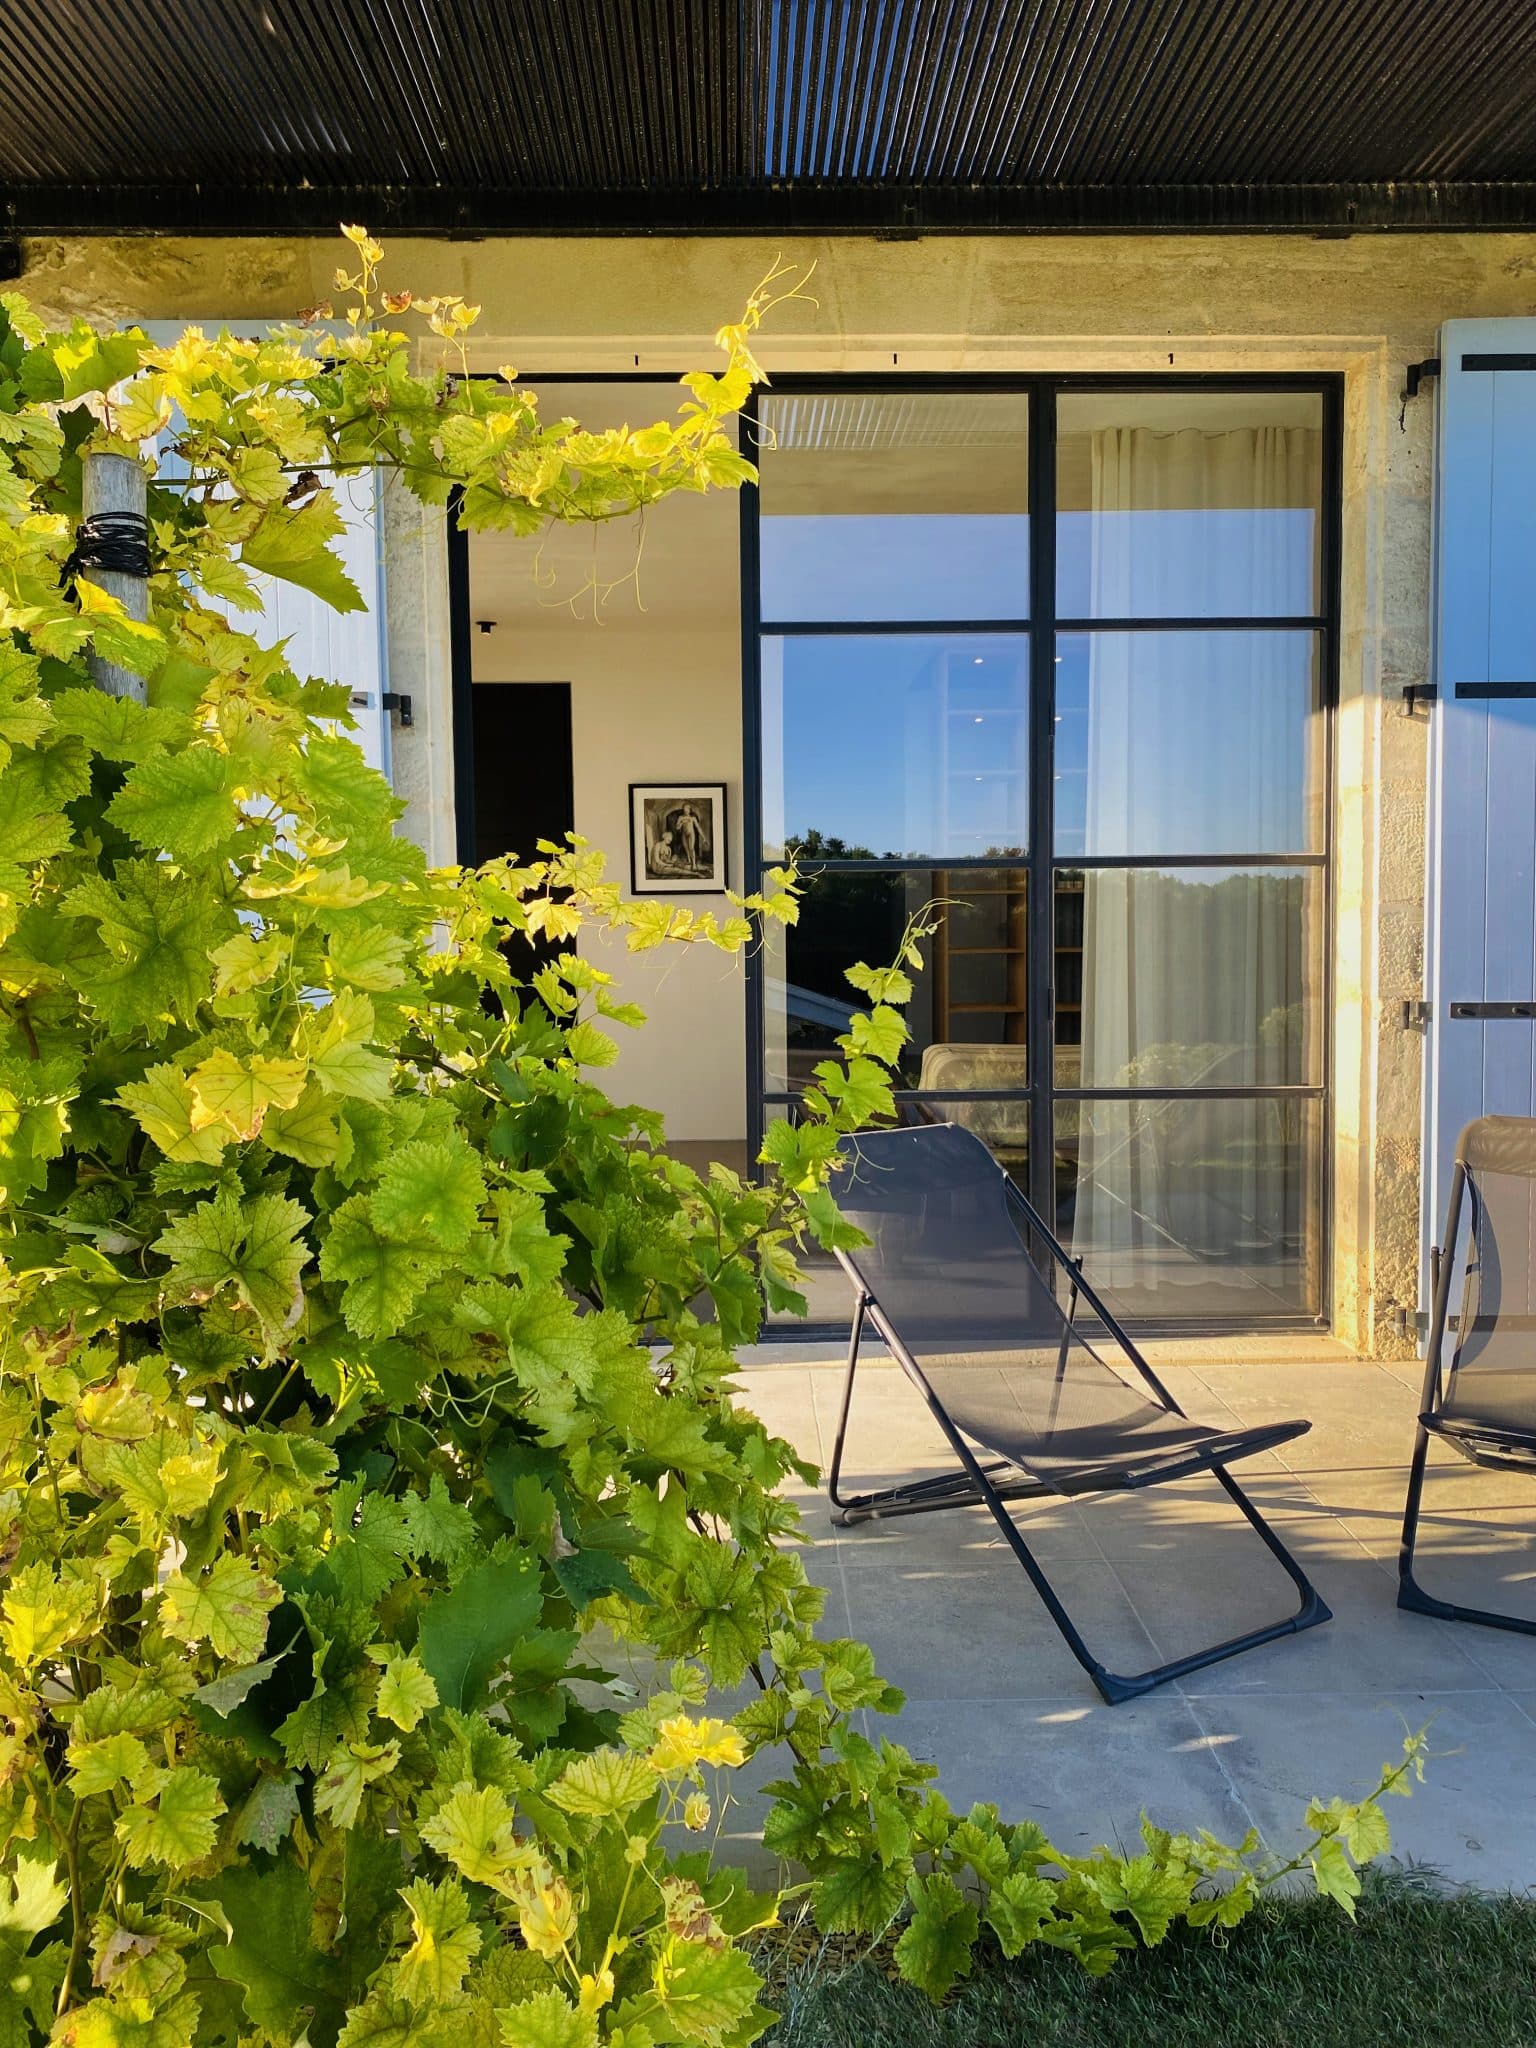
[881,1694,1251,1855]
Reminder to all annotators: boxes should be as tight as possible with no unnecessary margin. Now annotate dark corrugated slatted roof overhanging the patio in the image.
[0,0,1536,233]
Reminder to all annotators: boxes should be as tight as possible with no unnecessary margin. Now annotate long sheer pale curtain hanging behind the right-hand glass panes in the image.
[1073,426,1319,1313]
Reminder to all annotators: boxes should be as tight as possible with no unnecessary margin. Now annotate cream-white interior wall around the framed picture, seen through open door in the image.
[469,383,745,1143]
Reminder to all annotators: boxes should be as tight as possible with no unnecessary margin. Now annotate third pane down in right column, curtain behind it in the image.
[1057,868,1323,1087]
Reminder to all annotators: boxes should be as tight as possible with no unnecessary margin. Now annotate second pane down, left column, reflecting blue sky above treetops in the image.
[762,633,1030,860]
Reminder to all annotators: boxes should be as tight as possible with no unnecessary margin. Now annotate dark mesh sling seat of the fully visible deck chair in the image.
[831,1124,1305,1481]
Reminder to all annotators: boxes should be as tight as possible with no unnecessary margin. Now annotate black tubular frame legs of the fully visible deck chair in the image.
[827,1294,1333,1706]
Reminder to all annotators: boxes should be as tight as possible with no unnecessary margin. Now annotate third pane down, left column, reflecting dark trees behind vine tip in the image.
[764,868,1028,1089]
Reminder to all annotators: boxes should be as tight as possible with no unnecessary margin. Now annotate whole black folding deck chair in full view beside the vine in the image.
[827,1124,1329,1702]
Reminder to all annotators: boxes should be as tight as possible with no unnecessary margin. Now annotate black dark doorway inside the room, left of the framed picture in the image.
[469,682,575,862]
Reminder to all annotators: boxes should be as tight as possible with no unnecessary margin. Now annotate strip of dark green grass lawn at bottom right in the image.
[764,1876,1536,2048]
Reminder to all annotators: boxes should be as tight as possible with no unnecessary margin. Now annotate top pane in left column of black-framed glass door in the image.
[754,391,1030,621]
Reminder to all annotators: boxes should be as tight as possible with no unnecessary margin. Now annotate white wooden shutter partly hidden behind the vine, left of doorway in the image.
[145,319,391,774]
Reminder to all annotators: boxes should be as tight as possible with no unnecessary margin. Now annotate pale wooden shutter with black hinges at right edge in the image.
[1419,319,1536,1309]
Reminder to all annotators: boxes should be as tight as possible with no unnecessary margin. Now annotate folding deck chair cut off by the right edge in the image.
[1397,1116,1536,1636]
